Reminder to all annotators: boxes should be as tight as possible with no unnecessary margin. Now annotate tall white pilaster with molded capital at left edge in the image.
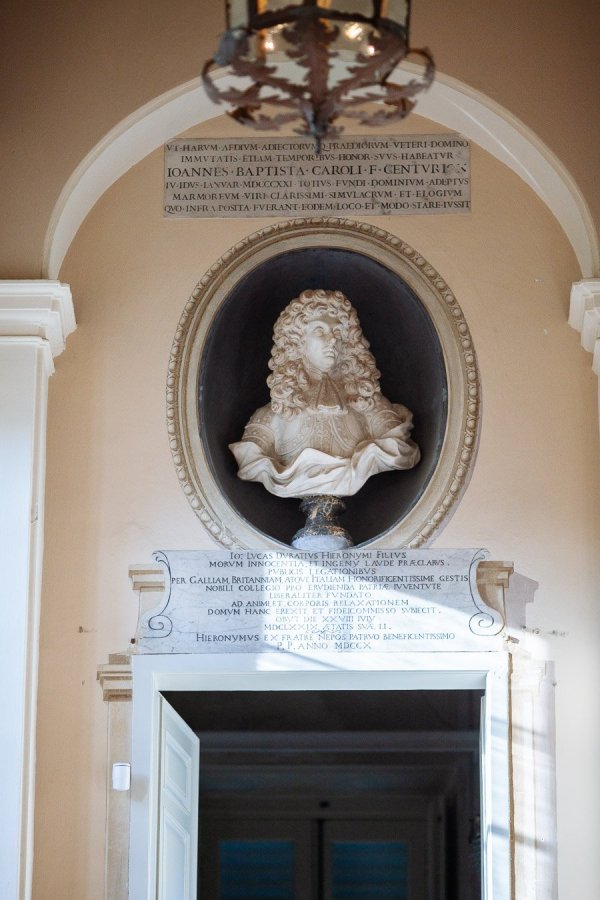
[0,281,75,900]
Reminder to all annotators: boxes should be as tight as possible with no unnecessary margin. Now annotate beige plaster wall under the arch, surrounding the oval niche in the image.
[34,118,600,900]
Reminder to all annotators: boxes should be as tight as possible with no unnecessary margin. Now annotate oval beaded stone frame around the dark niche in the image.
[167,218,481,550]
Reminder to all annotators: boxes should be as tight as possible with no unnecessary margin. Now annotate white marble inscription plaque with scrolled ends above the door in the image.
[131,550,507,656]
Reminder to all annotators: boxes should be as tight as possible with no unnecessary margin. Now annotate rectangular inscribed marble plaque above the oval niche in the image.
[164,134,471,218]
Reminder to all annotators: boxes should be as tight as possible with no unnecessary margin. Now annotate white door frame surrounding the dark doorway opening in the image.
[129,651,513,900]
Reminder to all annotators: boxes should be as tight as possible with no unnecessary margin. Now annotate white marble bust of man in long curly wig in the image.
[229,290,420,497]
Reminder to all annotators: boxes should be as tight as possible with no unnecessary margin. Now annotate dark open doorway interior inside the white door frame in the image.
[163,690,483,900]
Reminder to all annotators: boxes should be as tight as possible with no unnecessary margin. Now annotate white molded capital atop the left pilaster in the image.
[0,279,76,356]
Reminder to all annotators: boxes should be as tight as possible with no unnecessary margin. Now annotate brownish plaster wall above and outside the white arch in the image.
[0,0,600,278]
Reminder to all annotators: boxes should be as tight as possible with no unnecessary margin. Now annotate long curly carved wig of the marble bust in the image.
[267,290,381,419]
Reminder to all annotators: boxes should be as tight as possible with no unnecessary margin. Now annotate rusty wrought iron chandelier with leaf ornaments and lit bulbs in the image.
[202,0,435,153]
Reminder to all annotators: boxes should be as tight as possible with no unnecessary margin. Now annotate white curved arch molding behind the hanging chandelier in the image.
[43,65,600,278]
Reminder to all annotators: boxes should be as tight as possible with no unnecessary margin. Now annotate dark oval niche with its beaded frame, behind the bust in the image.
[167,219,480,549]
